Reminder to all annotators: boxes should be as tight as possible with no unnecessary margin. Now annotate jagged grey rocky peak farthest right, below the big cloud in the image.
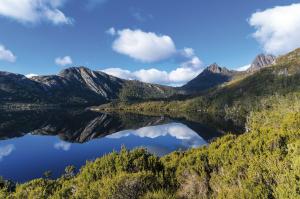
[247,54,276,72]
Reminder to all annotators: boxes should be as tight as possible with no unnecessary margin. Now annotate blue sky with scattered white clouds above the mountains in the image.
[0,0,300,86]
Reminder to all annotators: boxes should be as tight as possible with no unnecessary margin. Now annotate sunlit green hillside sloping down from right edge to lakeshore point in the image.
[104,49,300,125]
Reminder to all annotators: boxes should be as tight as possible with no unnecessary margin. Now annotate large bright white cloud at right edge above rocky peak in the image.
[249,3,300,55]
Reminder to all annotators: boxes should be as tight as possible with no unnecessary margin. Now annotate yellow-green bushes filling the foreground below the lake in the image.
[0,96,300,199]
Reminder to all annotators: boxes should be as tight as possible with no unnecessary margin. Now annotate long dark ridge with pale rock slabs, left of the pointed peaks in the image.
[0,67,178,106]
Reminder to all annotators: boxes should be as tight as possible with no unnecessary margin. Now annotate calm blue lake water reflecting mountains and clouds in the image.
[0,110,221,182]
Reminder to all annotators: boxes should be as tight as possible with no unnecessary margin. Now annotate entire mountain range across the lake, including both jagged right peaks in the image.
[0,54,276,106]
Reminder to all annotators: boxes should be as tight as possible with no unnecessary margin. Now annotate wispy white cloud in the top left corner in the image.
[0,0,73,25]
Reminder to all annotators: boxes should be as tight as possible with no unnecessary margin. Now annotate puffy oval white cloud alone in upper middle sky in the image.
[113,29,176,62]
